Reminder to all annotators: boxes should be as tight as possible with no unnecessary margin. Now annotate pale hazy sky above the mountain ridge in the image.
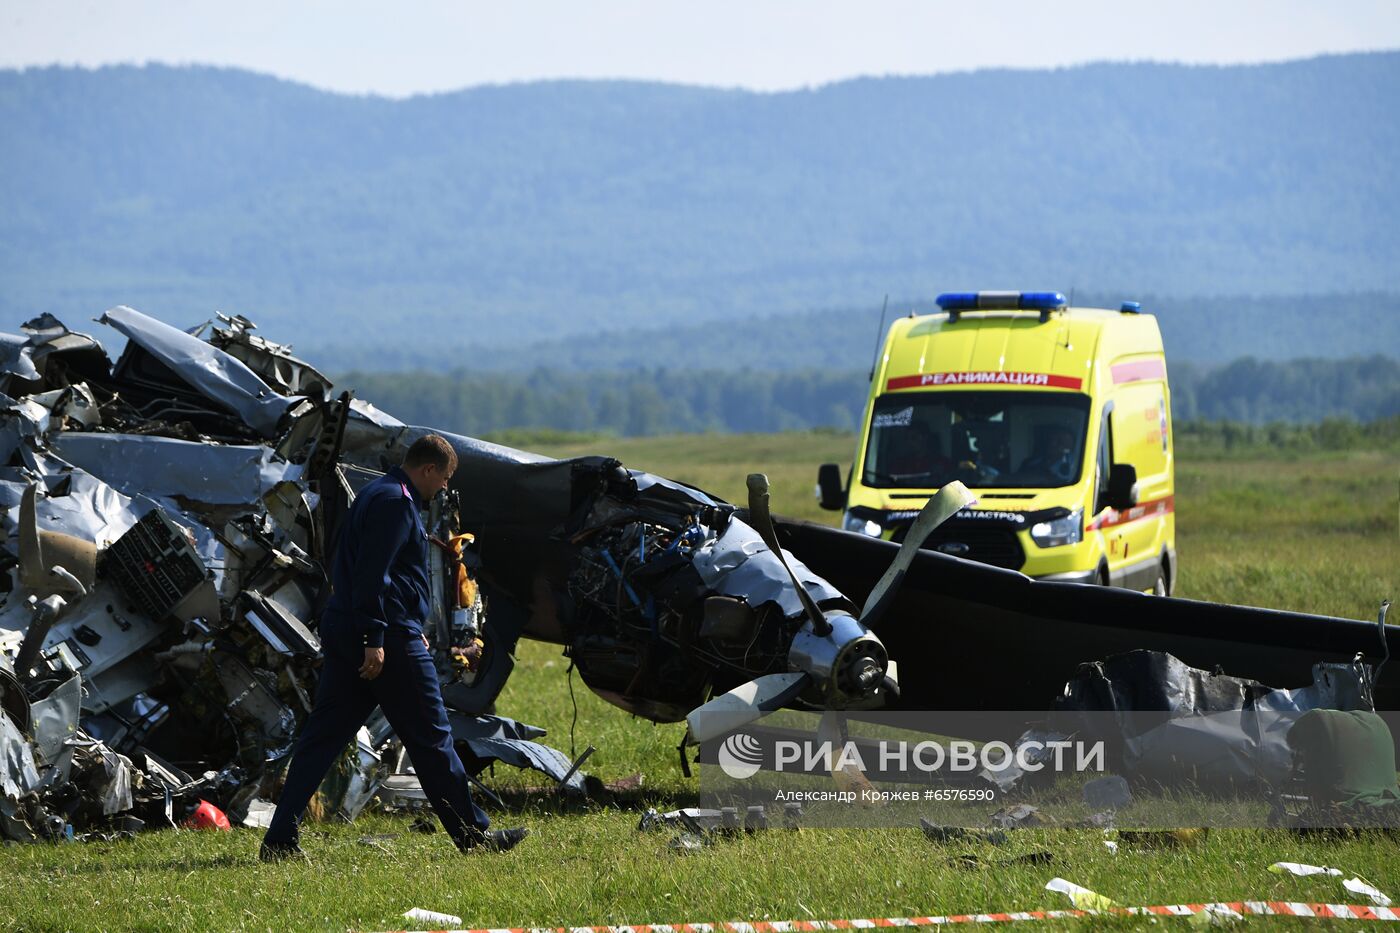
[0,0,1400,97]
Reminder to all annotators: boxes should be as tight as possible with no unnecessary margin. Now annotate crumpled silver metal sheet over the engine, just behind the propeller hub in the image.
[694,518,843,619]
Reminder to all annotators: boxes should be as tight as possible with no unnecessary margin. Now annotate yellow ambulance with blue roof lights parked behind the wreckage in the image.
[818,291,1176,595]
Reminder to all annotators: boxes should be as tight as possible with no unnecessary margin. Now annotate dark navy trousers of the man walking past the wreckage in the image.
[265,612,490,845]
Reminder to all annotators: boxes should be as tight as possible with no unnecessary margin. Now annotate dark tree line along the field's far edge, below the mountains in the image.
[337,356,1400,437]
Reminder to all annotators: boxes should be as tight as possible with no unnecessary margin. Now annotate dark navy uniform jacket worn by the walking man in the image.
[325,467,428,647]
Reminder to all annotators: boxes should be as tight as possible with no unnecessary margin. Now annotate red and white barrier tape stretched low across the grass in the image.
[380,901,1400,933]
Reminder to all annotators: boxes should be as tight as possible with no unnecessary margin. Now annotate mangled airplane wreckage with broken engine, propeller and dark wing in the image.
[0,307,1400,839]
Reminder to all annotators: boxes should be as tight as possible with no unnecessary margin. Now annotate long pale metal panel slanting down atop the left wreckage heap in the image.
[99,305,297,437]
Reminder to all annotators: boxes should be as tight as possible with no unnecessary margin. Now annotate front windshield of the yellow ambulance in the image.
[861,391,1089,489]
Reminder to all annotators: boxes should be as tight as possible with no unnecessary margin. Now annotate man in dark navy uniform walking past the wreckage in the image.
[260,434,529,862]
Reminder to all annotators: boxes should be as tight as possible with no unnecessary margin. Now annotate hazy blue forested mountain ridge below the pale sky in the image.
[0,52,1400,368]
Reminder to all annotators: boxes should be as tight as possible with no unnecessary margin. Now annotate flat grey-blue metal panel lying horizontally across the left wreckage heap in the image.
[49,431,301,509]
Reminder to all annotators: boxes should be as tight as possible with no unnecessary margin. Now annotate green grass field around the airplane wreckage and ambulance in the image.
[0,433,1400,930]
